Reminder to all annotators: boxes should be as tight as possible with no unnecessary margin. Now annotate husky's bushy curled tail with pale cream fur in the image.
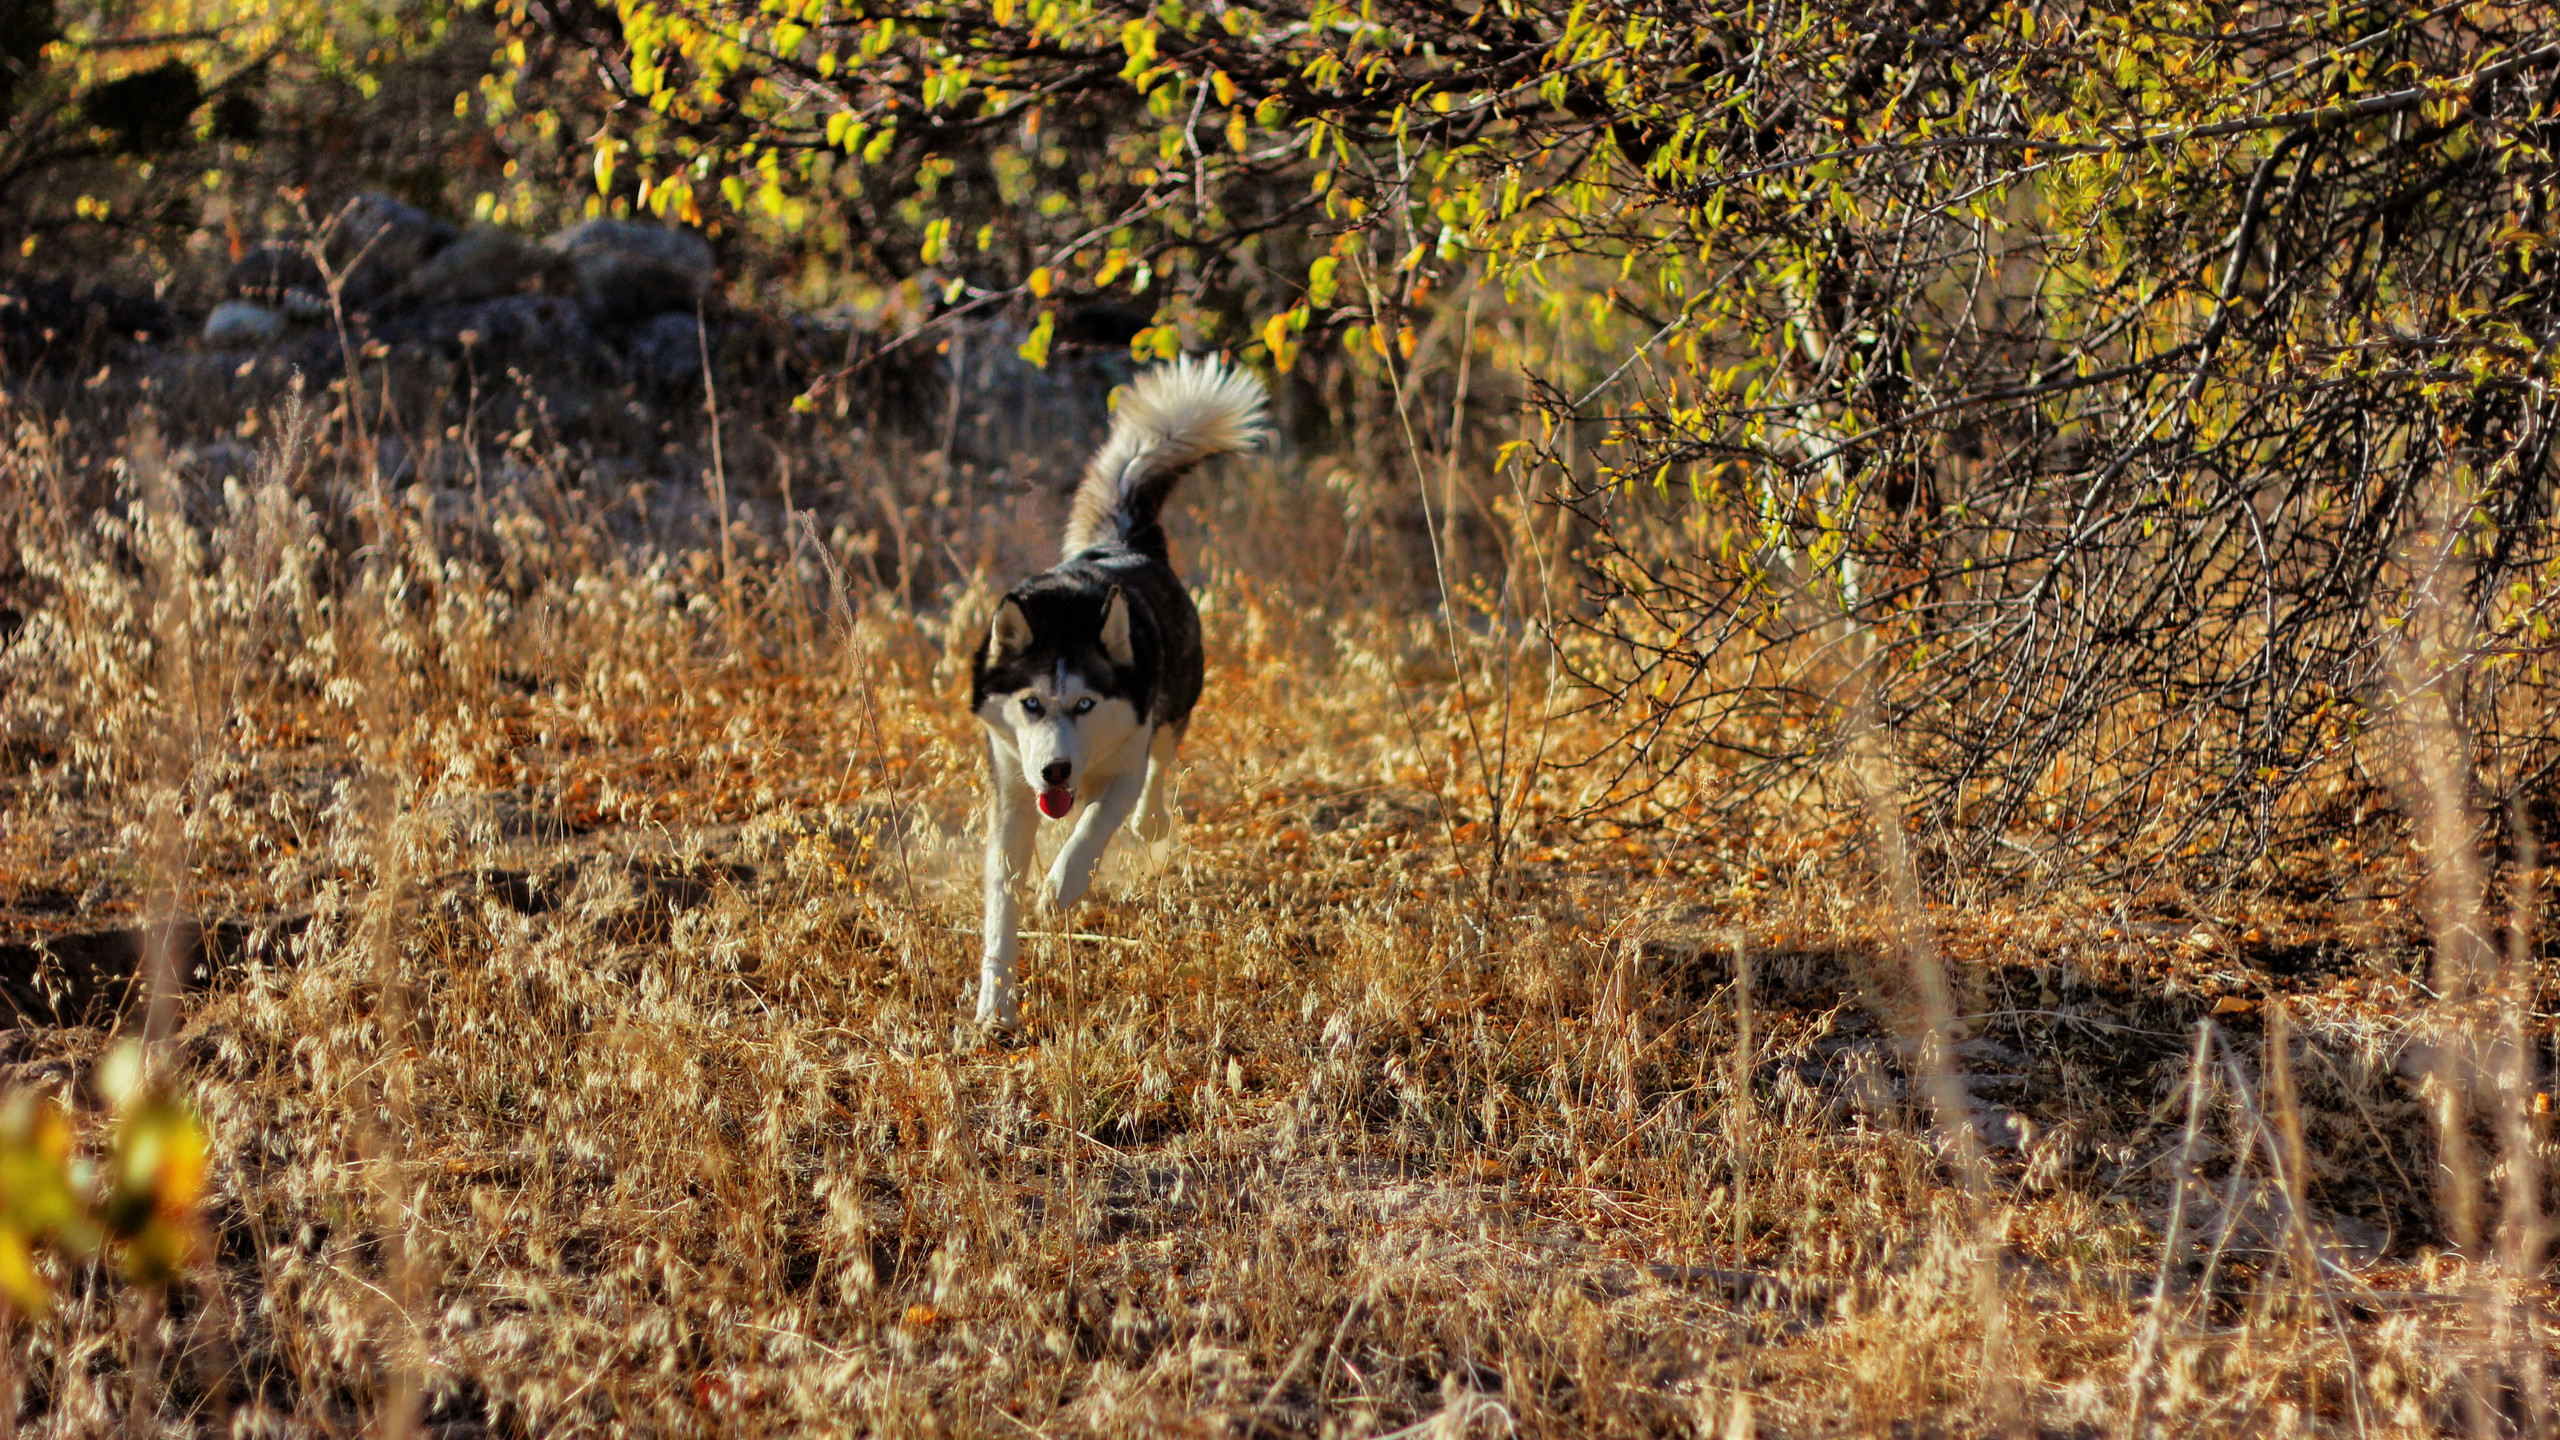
[1065,356,1270,556]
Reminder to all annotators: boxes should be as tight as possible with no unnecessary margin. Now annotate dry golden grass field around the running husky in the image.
[0,371,2560,1437]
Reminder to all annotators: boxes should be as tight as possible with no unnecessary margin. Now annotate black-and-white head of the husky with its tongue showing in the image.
[975,576,1139,820]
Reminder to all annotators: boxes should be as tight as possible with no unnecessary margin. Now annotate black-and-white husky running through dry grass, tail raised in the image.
[970,359,1265,1025]
